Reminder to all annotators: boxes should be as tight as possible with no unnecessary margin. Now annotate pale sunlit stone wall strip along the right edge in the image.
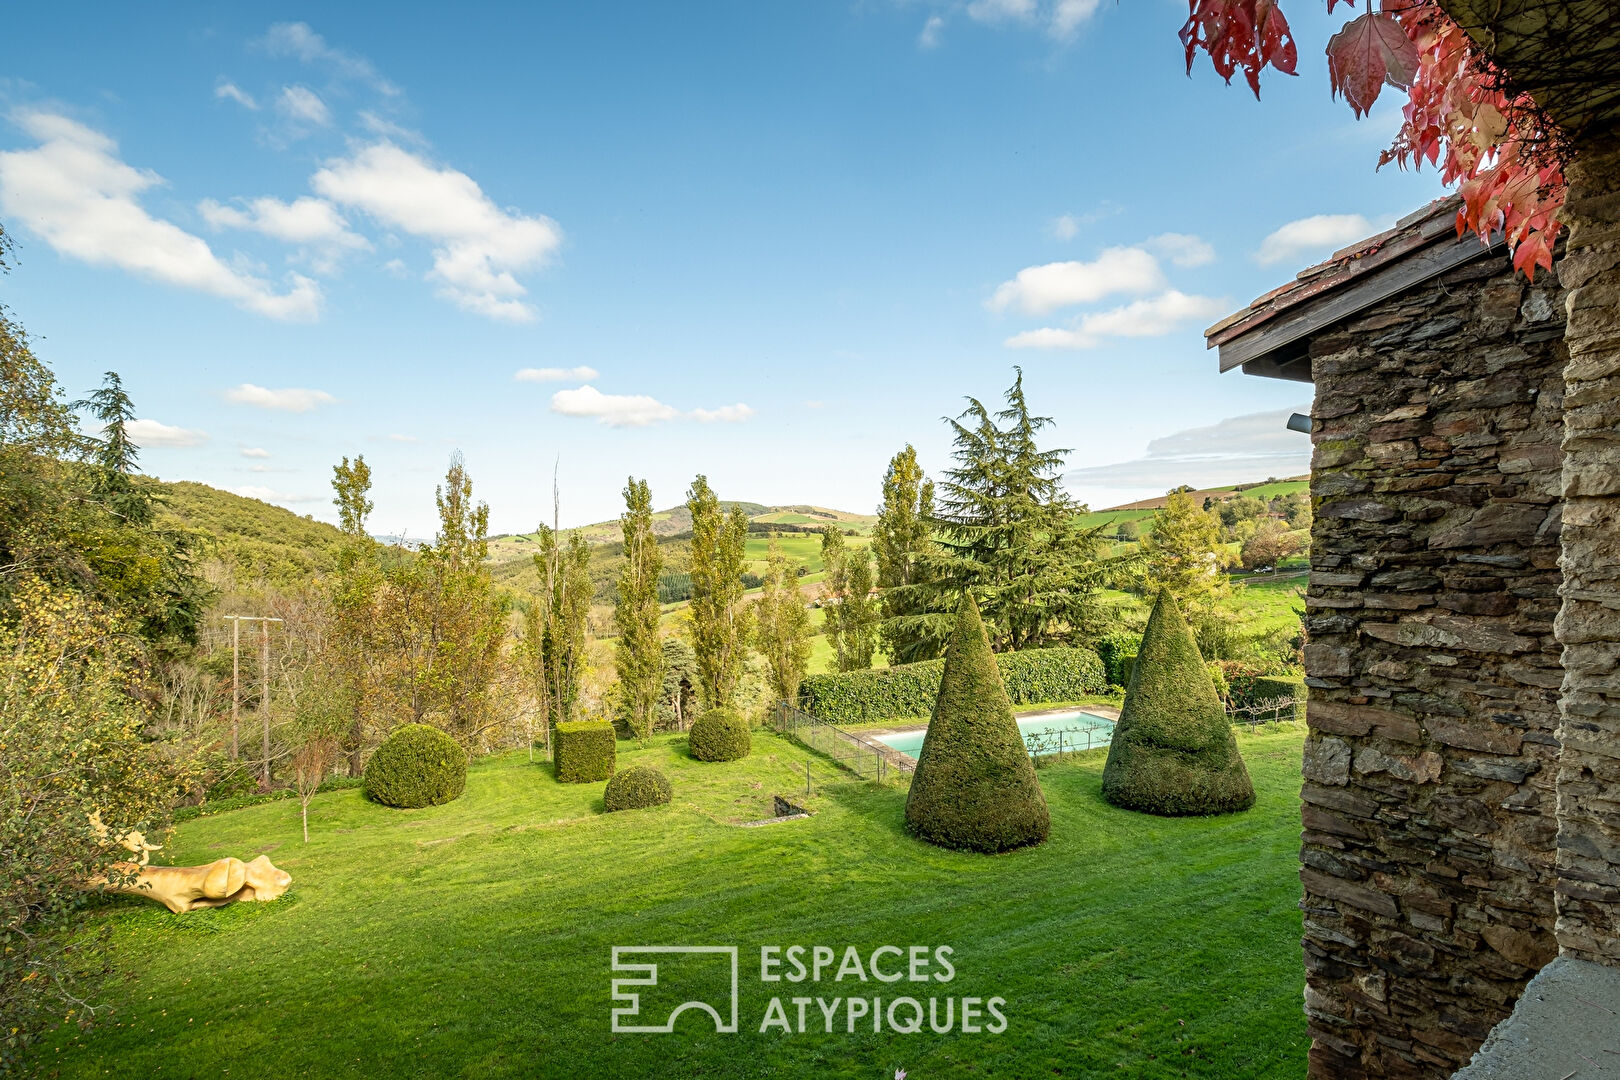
[1557,134,1620,965]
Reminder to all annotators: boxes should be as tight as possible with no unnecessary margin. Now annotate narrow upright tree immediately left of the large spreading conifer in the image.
[872,444,935,664]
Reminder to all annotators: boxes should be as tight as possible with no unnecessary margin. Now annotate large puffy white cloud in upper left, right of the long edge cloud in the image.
[311,142,562,322]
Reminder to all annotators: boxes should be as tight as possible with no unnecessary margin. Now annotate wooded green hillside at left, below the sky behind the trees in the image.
[157,481,343,586]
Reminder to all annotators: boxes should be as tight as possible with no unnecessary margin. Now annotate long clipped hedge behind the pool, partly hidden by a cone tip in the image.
[799,649,1108,724]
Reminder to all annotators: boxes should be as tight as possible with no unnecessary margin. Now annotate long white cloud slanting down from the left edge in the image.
[0,110,321,319]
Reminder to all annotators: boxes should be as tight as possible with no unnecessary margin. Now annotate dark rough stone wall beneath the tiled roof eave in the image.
[1301,256,1561,1077]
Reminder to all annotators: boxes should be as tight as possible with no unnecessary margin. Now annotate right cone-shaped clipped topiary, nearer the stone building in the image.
[1103,593,1254,816]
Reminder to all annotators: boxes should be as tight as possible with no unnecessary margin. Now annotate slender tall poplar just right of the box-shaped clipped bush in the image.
[614,476,664,746]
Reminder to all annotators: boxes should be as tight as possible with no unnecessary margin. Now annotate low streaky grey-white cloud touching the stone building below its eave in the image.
[1063,405,1311,502]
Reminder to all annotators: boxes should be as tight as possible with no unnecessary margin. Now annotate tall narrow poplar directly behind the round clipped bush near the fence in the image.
[687,476,748,709]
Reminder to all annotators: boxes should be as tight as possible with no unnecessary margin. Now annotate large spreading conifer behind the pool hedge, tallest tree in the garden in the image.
[891,371,1115,659]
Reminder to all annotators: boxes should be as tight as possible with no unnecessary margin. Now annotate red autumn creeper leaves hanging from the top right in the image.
[1181,0,1576,275]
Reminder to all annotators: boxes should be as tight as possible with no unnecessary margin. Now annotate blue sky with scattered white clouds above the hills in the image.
[0,0,1440,536]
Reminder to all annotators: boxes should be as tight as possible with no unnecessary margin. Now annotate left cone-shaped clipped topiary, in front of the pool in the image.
[906,597,1051,852]
